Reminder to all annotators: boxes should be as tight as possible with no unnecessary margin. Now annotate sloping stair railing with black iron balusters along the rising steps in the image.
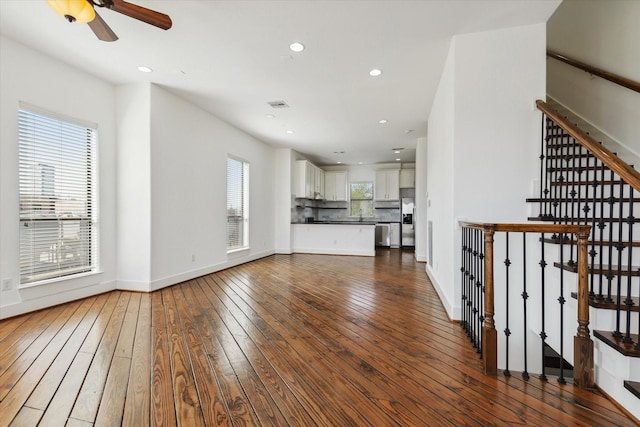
[531,100,640,352]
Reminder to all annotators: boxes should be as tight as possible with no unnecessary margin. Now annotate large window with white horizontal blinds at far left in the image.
[18,109,97,284]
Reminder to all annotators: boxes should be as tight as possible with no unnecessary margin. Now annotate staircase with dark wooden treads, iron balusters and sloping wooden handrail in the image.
[527,101,640,417]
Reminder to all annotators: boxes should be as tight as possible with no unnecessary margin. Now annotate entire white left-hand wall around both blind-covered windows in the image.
[0,38,276,317]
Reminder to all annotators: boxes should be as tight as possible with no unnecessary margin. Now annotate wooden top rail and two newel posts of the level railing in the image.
[458,221,595,388]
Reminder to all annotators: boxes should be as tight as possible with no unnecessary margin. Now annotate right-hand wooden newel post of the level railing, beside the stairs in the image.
[573,226,595,388]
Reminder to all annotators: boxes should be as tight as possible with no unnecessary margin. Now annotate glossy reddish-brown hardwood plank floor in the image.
[0,250,635,426]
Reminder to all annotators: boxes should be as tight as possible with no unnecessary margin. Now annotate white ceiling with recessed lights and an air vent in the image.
[0,0,559,165]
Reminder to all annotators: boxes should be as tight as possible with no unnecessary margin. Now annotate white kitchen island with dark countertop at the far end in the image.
[291,221,376,256]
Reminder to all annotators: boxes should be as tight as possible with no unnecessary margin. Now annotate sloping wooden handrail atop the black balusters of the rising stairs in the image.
[536,99,640,191]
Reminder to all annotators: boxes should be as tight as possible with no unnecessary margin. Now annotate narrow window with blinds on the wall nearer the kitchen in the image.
[227,157,249,252]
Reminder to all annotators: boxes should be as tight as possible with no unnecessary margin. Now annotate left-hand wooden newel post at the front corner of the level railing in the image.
[482,226,498,375]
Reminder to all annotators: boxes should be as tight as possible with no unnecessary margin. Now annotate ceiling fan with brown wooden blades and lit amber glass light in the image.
[47,0,172,42]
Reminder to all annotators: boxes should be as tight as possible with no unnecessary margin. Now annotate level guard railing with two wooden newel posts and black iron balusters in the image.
[459,221,594,388]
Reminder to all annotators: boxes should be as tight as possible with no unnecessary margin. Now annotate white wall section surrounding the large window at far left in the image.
[0,37,116,317]
